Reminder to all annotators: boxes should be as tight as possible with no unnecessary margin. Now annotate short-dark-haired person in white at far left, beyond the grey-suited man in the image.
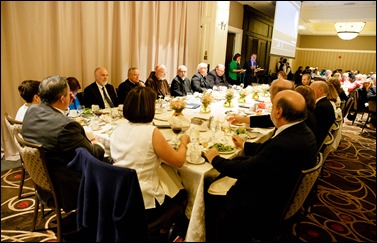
[15,80,41,121]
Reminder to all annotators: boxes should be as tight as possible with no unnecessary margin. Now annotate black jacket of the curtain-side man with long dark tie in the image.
[84,81,119,109]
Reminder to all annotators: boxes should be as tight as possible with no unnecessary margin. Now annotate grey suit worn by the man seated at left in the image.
[21,103,105,211]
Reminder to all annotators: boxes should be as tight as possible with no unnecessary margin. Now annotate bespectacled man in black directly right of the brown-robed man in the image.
[170,65,192,96]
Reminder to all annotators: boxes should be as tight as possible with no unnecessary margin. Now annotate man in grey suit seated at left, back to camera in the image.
[21,76,105,212]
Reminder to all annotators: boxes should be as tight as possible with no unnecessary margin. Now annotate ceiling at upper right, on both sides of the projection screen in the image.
[238,1,376,36]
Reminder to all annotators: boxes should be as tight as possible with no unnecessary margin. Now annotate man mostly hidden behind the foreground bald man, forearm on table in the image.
[229,79,294,128]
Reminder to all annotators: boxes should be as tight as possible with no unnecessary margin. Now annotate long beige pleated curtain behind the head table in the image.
[1,1,201,159]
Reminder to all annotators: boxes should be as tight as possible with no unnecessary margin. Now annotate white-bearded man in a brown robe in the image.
[145,64,170,98]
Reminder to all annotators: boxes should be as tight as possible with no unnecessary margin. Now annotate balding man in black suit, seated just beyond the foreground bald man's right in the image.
[310,81,335,149]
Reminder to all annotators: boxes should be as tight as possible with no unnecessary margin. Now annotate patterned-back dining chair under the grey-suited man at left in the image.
[15,132,62,242]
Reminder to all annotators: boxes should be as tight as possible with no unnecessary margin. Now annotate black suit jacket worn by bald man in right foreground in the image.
[212,122,317,235]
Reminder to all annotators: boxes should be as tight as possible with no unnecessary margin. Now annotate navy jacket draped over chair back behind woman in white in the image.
[68,148,148,242]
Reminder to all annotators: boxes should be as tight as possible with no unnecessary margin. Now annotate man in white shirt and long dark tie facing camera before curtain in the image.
[84,67,118,109]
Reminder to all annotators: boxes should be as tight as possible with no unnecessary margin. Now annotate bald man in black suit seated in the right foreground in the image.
[205,90,317,242]
